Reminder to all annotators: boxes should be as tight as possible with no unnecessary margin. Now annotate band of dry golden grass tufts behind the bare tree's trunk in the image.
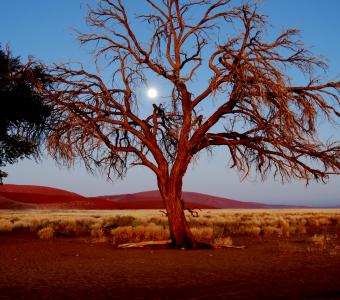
[0,209,340,245]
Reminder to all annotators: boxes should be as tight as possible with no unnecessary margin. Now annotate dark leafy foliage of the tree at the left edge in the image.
[0,48,52,184]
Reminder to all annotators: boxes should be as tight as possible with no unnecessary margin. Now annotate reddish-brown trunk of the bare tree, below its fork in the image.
[160,180,197,249]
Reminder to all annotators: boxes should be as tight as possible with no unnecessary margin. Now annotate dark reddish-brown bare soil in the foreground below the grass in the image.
[0,234,340,300]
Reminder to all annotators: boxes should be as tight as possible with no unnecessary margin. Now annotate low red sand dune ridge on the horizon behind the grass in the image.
[0,184,290,209]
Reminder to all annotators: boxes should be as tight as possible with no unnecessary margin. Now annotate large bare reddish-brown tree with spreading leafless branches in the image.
[41,0,340,248]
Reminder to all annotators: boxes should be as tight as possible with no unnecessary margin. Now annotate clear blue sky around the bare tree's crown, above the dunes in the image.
[0,0,340,206]
